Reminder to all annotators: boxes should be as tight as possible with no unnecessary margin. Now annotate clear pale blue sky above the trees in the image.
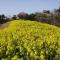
[0,0,60,15]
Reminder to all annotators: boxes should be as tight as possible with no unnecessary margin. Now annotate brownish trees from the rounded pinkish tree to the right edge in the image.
[17,7,60,27]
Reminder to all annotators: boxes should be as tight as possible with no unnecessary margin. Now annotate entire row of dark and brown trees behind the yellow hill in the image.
[0,7,60,26]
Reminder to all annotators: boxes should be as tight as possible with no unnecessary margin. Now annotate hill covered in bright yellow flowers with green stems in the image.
[0,20,60,60]
